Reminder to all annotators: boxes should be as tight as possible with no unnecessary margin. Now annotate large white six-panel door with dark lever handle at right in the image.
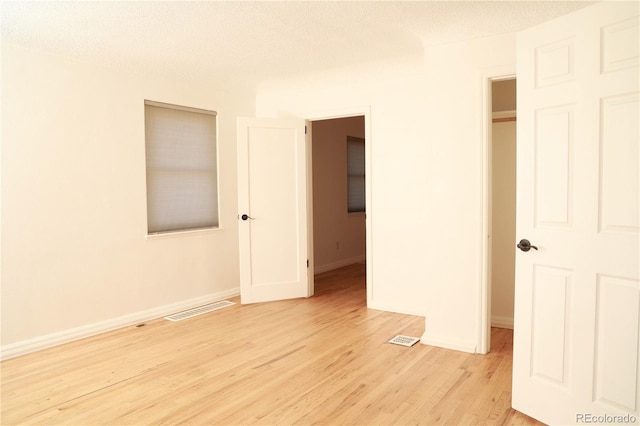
[513,2,640,424]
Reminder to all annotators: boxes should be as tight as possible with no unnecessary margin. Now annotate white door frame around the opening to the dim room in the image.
[305,105,373,306]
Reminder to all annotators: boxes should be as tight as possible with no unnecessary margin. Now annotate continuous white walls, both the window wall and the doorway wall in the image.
[2,30,515,357]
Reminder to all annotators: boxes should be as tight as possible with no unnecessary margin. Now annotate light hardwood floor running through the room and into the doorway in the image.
[0,265,539,425]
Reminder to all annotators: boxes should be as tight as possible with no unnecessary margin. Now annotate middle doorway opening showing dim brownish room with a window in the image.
[311,115,367,298]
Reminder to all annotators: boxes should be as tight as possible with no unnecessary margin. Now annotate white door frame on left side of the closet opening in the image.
[476,70,517,354]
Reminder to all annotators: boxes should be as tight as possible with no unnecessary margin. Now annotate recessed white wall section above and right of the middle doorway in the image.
[256,54,427,315]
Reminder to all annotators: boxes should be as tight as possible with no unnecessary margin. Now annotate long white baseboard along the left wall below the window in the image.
[0,288,240,360]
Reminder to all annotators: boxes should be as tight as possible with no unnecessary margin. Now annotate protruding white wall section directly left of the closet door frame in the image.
[423,34,516,352]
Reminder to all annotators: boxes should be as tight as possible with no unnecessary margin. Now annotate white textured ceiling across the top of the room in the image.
[0,0,593,83]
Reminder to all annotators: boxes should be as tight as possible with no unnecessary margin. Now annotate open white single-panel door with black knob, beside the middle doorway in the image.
[238,118,310,303]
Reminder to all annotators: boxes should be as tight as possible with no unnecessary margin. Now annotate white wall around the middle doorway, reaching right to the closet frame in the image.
[256,34,515,352]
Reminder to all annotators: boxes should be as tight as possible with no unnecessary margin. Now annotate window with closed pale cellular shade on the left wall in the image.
[144,101,218,234]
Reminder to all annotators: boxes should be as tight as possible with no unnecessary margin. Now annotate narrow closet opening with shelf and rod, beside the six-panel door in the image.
[486,78,517,350]
